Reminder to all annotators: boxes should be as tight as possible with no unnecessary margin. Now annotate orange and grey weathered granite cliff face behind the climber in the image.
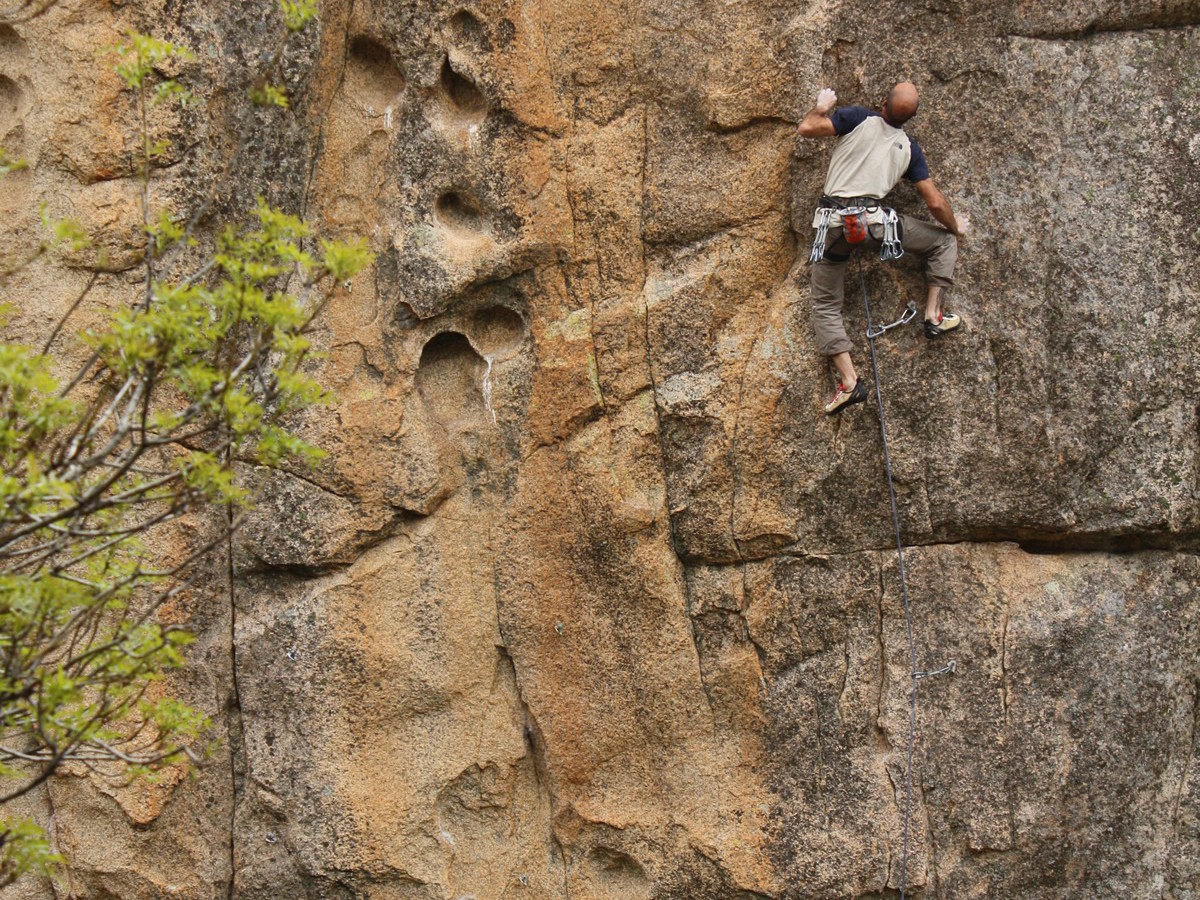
[0,0,1200,900]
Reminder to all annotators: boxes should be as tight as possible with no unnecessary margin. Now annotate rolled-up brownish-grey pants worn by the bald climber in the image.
[812,216,959,356]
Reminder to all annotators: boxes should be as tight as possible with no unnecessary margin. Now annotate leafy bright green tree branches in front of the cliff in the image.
[0,0,371,887]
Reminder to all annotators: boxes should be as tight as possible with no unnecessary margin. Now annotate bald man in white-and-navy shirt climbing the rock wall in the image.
[799,82,971,415]
